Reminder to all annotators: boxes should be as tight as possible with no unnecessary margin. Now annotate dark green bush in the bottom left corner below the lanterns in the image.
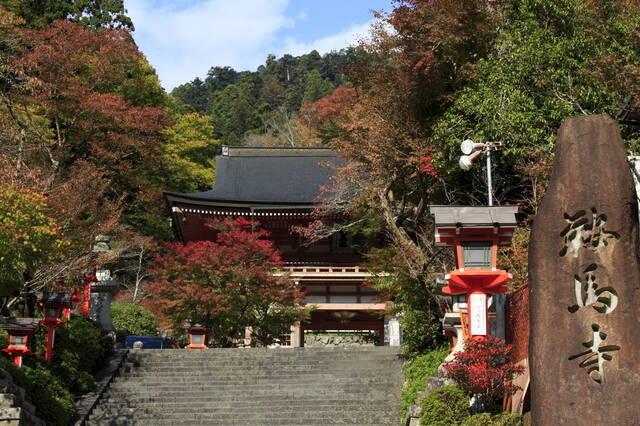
[0,357,76,426]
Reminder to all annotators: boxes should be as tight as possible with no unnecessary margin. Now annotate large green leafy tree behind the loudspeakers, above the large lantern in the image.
[432,0,640,208]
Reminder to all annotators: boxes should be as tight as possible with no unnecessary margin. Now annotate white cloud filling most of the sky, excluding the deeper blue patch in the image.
[125,0,376,90]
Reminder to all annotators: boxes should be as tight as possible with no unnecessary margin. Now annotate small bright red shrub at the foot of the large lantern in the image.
[444,337,524,400]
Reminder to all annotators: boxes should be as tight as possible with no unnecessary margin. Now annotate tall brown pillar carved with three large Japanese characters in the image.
[529,114,640,426]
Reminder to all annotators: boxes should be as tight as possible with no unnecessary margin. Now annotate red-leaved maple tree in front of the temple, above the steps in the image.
[151,217,305,345]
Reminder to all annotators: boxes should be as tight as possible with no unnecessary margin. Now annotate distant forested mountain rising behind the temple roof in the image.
[171,48,363,145]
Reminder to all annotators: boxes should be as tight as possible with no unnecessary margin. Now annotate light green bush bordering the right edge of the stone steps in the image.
[401,345,449,413]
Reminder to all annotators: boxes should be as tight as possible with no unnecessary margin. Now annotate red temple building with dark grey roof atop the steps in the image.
[165,146,400,346]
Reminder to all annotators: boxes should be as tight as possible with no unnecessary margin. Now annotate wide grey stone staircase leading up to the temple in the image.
[87,347,403,426]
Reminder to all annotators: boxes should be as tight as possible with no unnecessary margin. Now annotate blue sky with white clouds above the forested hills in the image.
[125,0,391,91]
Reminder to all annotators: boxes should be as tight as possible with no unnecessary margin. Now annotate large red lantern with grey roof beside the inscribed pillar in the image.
[430,206,518,346]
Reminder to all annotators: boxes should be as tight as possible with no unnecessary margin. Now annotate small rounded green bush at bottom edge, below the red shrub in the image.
[420,385,469,426]
